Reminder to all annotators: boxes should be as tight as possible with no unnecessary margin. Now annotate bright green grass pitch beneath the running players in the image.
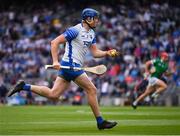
[0,106,180,136]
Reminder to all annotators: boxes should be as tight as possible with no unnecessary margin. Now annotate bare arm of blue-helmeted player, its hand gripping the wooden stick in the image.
[51,34,66,69]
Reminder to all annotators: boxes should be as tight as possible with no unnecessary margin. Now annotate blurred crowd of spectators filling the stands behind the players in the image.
[0,1,180,104]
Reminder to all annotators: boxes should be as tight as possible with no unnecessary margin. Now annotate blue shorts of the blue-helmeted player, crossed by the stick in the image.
[58,61,84,82]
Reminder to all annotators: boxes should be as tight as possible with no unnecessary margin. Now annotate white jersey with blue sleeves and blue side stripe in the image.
[62,24,96,66]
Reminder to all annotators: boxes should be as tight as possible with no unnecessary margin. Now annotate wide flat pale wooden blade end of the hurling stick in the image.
[84,65,107,75]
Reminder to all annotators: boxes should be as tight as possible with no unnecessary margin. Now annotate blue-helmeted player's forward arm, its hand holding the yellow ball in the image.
[90,44,118,58]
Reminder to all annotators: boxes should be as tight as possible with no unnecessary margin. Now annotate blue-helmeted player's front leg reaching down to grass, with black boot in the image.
[75,73,117,129]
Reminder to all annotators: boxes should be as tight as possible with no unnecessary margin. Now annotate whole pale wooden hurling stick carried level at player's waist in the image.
[45,65,107,75]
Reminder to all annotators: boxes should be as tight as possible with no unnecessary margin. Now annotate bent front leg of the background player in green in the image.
[152,79,167,98]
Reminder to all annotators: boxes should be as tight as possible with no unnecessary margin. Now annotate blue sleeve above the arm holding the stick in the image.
[63,27,79,41]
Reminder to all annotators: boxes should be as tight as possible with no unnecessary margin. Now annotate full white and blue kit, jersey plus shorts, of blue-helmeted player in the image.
[59,24,96,82]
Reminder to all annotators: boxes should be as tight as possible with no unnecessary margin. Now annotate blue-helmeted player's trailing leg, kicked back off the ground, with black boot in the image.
[8,77,69,100]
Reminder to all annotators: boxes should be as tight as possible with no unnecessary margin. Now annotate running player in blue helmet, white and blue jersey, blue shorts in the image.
[8,8,117,129]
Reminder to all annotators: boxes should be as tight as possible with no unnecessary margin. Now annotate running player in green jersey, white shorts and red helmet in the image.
[132,52,171,109]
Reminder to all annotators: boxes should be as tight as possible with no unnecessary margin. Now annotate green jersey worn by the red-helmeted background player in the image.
[151,58,168,78]
